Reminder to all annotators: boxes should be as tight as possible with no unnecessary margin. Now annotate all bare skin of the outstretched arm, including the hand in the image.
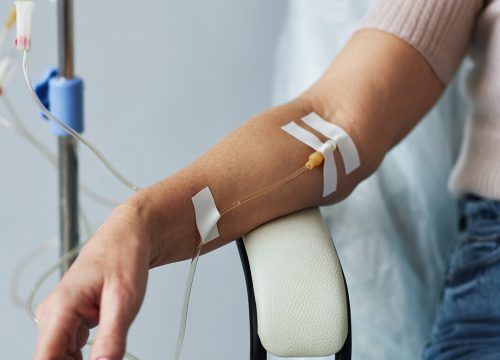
[35,30,444,360]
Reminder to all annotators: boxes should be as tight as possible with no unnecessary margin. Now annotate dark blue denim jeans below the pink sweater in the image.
[423,195,500,360]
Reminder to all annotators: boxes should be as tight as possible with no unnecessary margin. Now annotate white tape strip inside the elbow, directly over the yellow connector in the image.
[281,122,337,197]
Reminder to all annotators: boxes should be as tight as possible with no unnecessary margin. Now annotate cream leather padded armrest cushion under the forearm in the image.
[244,209,348,357]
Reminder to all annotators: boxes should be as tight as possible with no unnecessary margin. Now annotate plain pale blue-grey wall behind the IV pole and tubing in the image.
[0,0,285,359]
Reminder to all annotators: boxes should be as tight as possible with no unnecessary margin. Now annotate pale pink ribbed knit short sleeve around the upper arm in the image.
[360,0,485,83]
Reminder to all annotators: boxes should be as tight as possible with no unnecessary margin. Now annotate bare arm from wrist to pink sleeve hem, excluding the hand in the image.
[128,31,443,266]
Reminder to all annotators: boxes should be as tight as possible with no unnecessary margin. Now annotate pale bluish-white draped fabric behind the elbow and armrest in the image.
[271,0,463,360]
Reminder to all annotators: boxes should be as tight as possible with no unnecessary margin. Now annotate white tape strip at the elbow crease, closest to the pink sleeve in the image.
[302,113,361,175]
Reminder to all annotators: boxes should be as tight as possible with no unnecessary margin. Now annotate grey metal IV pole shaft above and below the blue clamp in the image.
[57,0,79,276]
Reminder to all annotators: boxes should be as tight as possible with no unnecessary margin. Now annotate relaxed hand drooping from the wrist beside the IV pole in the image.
[35,205,151,360]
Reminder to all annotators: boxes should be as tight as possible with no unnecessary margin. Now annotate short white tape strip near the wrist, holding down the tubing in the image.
[192,187,220,244]
